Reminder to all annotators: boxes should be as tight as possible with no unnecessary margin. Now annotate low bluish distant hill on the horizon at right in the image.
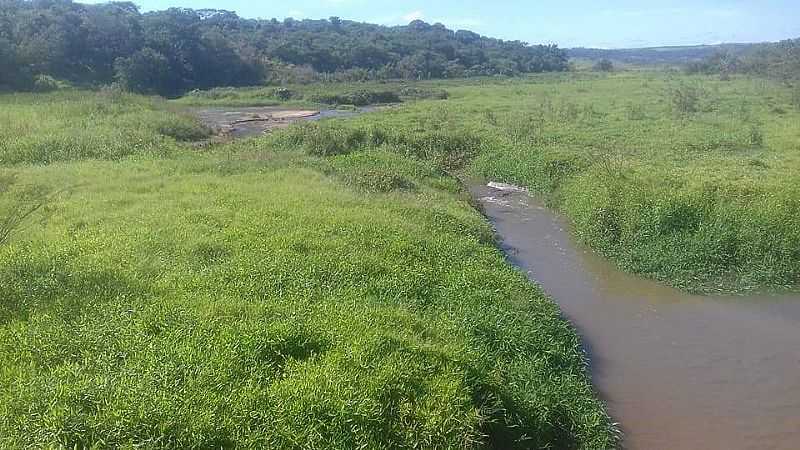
[567,44,762,65]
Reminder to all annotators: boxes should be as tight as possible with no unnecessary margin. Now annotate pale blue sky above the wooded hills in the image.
[85,0,800,48]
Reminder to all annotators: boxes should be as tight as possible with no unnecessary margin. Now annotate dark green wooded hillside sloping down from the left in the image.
[0,0,568,96]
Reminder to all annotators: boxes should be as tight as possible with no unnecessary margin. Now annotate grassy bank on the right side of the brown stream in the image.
[270,72,800,292]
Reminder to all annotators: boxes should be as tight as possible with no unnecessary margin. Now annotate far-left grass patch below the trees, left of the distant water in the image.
[0,91,209,165]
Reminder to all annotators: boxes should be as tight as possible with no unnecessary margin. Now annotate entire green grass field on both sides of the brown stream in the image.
[0,68,800,449]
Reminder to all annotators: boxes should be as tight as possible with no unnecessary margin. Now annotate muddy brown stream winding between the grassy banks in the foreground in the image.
[471,185,800,450]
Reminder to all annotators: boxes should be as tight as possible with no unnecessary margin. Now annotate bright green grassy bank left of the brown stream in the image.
[0,93,615,449]
